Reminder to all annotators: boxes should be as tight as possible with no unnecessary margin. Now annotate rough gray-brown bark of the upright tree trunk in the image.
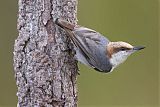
[14,0,78,107]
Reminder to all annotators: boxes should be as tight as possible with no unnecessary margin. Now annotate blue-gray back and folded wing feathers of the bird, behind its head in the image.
[74,27,111,71]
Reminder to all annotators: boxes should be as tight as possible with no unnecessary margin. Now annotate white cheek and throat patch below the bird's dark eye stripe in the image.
[110,51,131,69]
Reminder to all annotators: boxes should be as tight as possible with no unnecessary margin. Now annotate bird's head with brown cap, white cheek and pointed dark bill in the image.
[107,41,145,69]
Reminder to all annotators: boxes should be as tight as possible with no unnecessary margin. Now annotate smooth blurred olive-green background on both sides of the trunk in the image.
[0,0,159,107]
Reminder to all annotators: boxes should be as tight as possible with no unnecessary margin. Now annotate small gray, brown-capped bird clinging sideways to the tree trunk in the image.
[55,18,145,73]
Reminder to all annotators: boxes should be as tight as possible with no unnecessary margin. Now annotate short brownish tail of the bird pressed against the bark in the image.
[55,18,75,31]
